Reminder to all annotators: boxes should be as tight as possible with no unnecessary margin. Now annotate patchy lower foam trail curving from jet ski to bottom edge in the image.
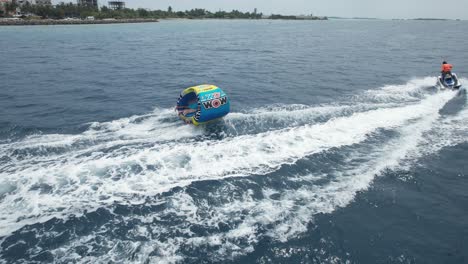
[140,91,460,262]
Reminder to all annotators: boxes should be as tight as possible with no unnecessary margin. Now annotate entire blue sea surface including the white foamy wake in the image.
[0,20,468,264]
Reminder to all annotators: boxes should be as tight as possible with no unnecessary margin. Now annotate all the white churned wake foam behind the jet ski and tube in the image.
[0,77,468,263]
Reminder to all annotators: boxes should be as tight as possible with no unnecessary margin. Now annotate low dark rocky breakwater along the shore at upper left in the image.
[0,19,159,26]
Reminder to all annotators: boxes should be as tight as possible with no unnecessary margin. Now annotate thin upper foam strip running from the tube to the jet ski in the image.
[225,77,436,135]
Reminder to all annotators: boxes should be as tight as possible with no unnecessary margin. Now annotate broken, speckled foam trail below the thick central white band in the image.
[39,89,453,263]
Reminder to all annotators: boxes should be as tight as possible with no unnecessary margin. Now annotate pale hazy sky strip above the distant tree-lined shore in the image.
[54,0,468,19]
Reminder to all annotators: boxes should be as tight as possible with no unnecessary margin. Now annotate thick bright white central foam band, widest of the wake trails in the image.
[0,89,453,239]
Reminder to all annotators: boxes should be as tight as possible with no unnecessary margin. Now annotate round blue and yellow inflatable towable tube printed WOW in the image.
[176,84,230,126]
